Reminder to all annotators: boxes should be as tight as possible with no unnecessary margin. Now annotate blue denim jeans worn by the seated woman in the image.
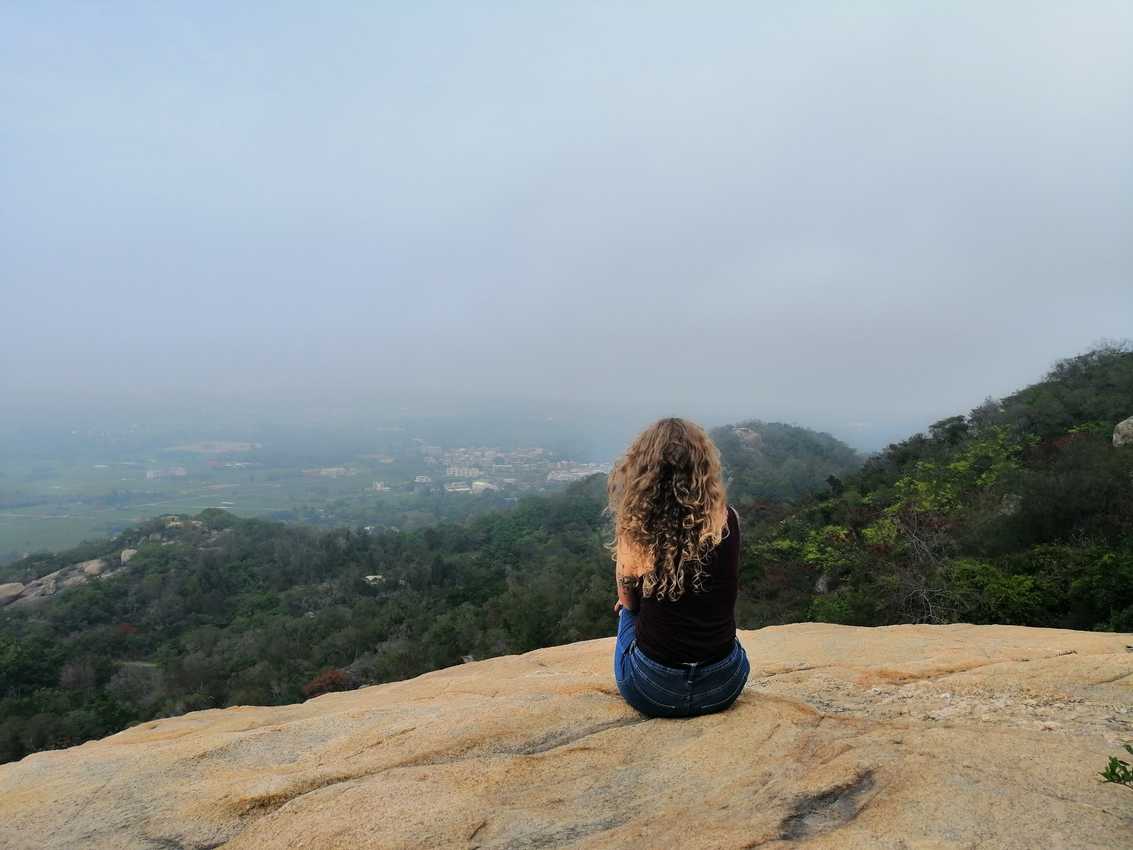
[614,607,751,717]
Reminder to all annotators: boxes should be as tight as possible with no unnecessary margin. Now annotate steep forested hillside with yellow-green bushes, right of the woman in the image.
[746,346,1133,631]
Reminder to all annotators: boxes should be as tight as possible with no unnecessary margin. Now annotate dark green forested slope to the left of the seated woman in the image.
[0,476,613,760]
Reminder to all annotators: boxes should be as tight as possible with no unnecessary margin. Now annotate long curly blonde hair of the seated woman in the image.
[606,418,727,602]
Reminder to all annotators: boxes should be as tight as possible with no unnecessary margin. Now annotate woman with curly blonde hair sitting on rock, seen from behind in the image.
[607,418,751,717]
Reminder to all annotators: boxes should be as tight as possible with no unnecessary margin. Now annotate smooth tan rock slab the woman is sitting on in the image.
[0,623,1133,850]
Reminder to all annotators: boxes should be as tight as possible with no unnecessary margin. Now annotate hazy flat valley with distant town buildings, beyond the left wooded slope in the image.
[0,427,611,562]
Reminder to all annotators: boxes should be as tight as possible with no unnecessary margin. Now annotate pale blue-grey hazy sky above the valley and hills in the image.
[0,0,1133,453]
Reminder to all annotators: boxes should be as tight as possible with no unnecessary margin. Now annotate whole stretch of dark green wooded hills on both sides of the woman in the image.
[0,347,1133,760]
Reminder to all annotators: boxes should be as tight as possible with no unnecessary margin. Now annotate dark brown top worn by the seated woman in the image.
[637,505,740,666]
